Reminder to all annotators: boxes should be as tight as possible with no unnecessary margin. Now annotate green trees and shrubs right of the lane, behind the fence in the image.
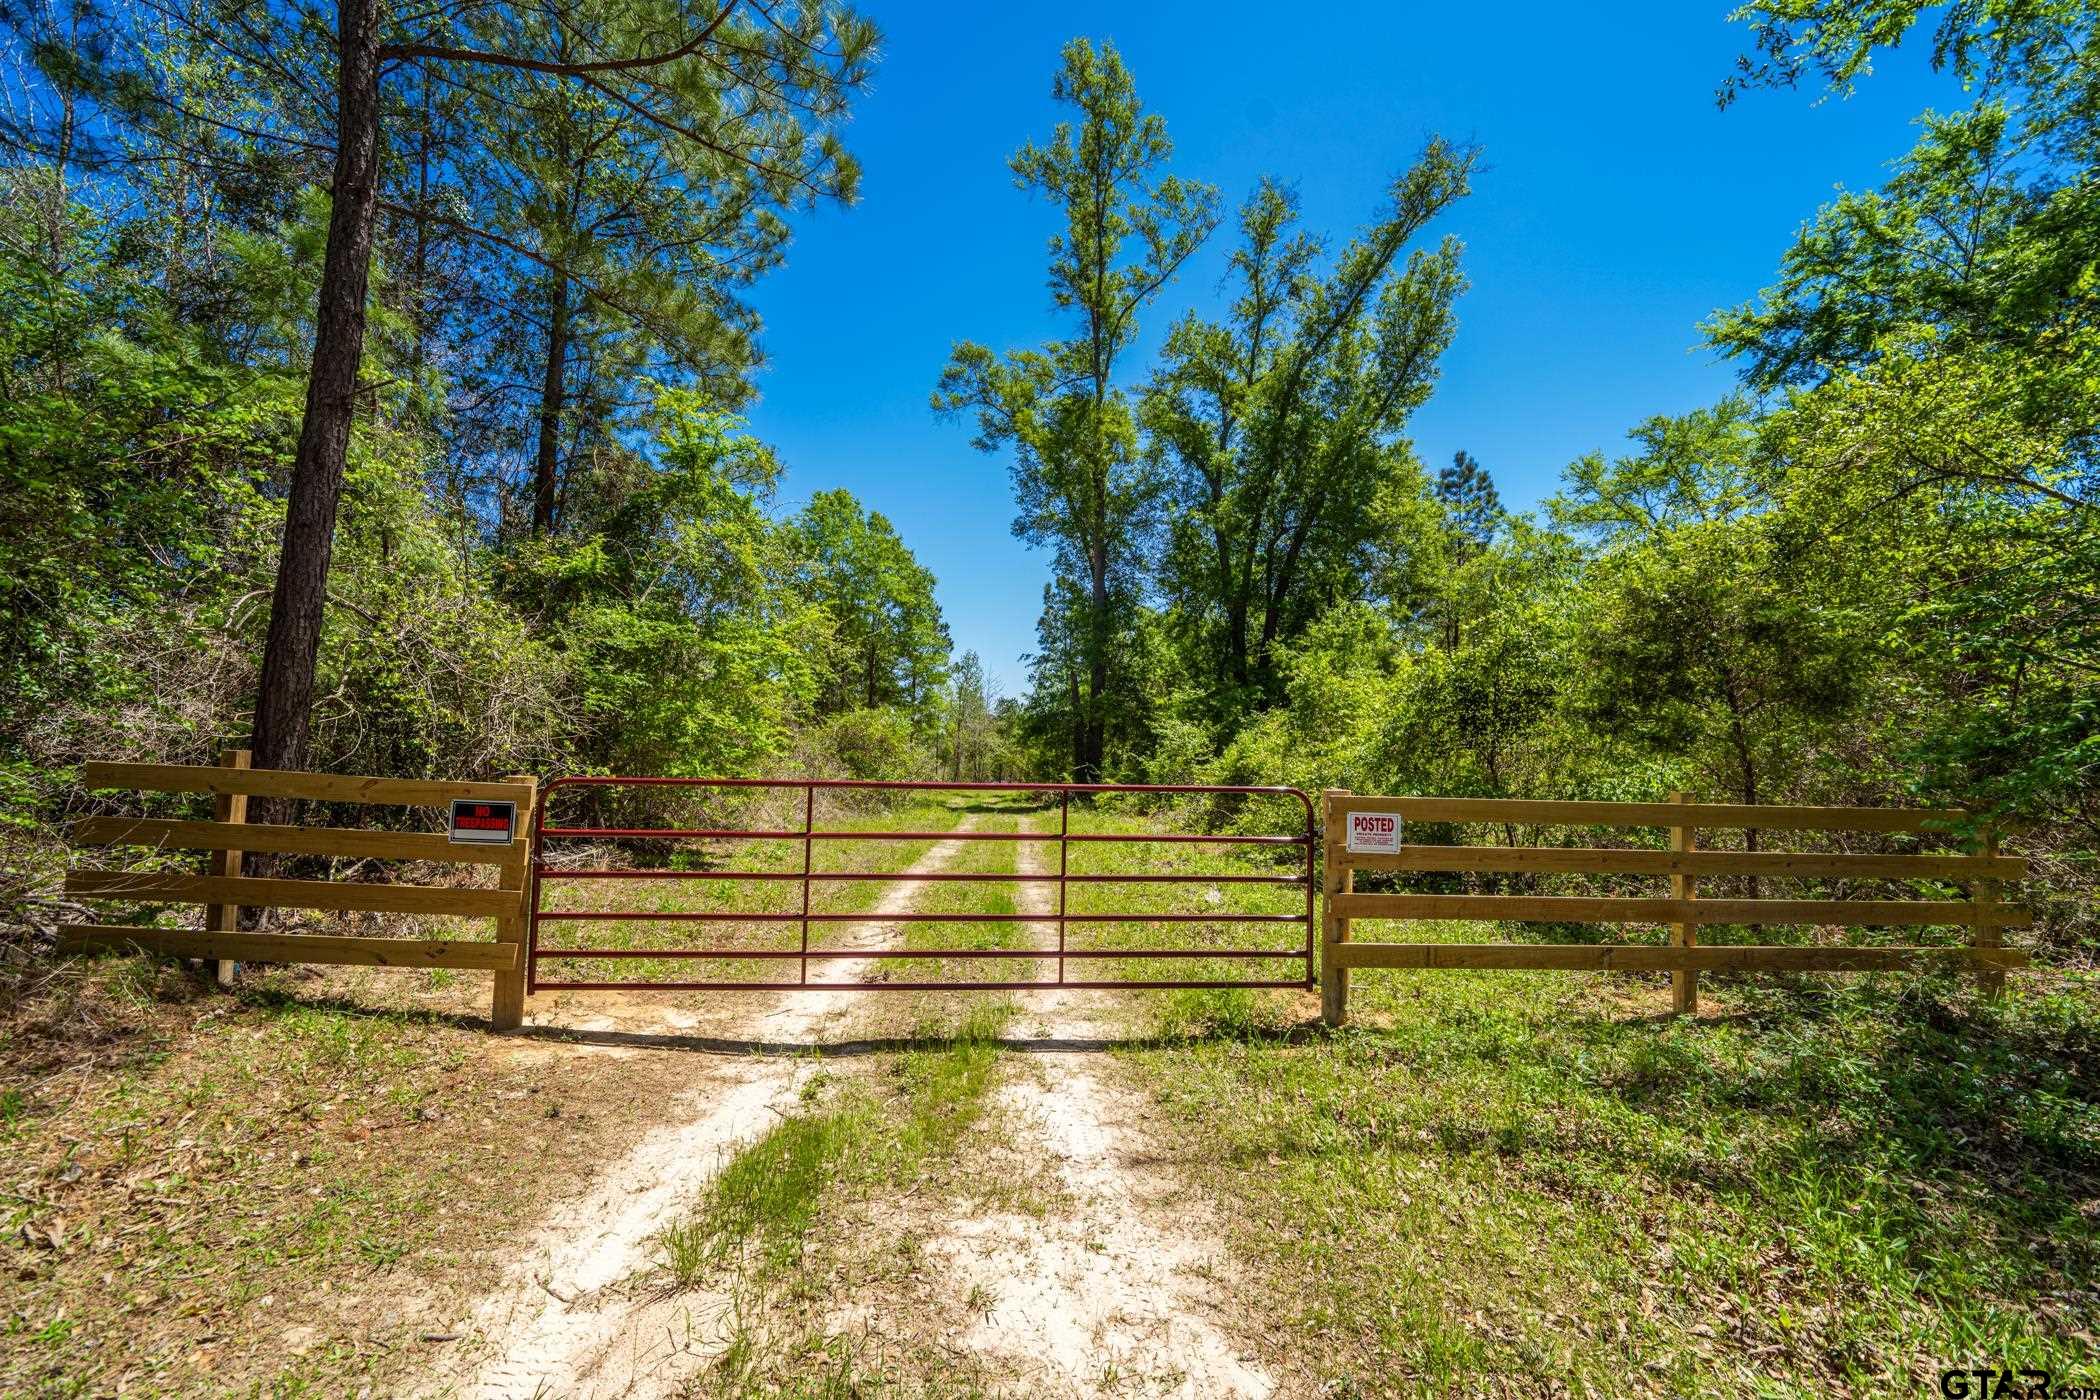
[932,19,2100,931]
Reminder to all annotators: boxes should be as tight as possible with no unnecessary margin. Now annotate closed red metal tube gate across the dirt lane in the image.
[525,777,1317,991]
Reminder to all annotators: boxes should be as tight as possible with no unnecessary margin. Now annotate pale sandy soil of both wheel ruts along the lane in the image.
[424,821,1277,1400]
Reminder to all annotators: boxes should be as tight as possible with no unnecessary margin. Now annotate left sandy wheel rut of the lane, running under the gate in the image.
[424,816,977,1400]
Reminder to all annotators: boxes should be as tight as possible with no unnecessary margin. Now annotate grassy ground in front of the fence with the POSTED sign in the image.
[1134,957,2100,1394]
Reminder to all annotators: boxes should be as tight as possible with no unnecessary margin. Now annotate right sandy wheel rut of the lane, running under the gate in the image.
[928,827,1277,1398]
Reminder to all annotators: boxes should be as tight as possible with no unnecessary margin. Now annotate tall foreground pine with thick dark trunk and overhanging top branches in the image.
[16,0,874,766]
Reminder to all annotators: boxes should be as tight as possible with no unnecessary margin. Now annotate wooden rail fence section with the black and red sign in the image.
[59,749,538,1031]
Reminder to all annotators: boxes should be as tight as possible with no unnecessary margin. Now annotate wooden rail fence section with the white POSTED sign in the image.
[1321,791,2031,1024]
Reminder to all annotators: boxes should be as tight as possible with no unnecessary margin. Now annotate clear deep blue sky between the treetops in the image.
[750,0,1961,695]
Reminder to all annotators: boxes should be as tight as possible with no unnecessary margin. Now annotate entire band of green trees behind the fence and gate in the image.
[0,0,2100,952]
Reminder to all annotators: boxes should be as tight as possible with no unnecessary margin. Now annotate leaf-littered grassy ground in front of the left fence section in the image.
[0,957,739,1396]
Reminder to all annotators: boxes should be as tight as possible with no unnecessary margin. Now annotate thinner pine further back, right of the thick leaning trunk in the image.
[454,29,823,533]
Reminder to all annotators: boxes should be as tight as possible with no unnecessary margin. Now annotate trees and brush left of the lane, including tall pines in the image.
[0,0,1014,910]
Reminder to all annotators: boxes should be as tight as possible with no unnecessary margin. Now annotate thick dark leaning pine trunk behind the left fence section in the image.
[252,0,380,776]
